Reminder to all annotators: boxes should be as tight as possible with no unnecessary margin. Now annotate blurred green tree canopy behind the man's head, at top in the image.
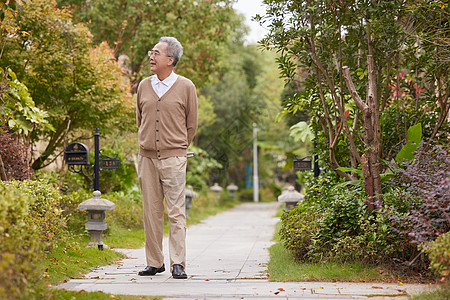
[58,0,246,91]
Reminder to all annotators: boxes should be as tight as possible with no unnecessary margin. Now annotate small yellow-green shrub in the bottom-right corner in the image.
[425,232,450,278]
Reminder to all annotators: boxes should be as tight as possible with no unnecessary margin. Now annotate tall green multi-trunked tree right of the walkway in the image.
[257,0,450,207]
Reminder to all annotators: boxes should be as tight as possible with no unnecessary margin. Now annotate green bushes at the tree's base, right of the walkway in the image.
[280,172,417,264]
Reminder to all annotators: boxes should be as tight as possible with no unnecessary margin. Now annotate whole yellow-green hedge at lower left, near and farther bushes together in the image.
[0,180,65,299]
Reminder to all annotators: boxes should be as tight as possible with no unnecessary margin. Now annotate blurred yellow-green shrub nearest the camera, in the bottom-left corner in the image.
[0,182,42,299]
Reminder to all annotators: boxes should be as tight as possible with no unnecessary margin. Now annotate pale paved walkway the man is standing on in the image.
[58,203,438,299]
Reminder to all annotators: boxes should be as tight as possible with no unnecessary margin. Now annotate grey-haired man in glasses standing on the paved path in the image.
[136,37,198,279]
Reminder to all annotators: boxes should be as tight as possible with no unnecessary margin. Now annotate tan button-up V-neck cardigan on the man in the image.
[136,76,198,159]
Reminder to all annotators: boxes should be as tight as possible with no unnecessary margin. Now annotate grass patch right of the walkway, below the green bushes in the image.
[269,242,380,282]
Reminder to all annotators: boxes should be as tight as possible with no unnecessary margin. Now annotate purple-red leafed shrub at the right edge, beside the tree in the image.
[385,143,450,246]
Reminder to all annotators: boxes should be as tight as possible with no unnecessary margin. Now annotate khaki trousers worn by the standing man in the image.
[138,155,186,271]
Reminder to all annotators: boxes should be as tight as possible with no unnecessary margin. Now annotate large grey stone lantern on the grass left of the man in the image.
[78,191,116,250]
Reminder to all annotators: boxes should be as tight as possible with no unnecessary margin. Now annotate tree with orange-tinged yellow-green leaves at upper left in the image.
[0,0,133,169]
